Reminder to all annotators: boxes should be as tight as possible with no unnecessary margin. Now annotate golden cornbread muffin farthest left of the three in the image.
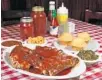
[58,33,73,46]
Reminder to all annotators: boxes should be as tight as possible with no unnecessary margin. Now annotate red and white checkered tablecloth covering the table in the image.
[1,19,102,80]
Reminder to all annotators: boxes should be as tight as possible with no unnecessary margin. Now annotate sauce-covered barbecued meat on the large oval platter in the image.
[10,46,78,76]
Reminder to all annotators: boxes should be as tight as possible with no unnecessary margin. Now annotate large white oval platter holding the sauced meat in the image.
[3,45,86,79]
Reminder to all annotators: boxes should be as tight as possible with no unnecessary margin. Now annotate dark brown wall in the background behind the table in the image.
[1,0,102,21]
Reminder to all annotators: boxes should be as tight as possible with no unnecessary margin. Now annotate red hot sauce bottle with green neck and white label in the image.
[50,10,59,35]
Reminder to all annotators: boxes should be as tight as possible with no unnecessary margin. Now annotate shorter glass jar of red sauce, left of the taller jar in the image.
[20,17,34,40]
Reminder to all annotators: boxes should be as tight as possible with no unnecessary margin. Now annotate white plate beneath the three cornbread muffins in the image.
[54,39,100,53]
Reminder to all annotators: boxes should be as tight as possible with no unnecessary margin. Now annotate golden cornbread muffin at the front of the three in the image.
[71,38,86,51]
